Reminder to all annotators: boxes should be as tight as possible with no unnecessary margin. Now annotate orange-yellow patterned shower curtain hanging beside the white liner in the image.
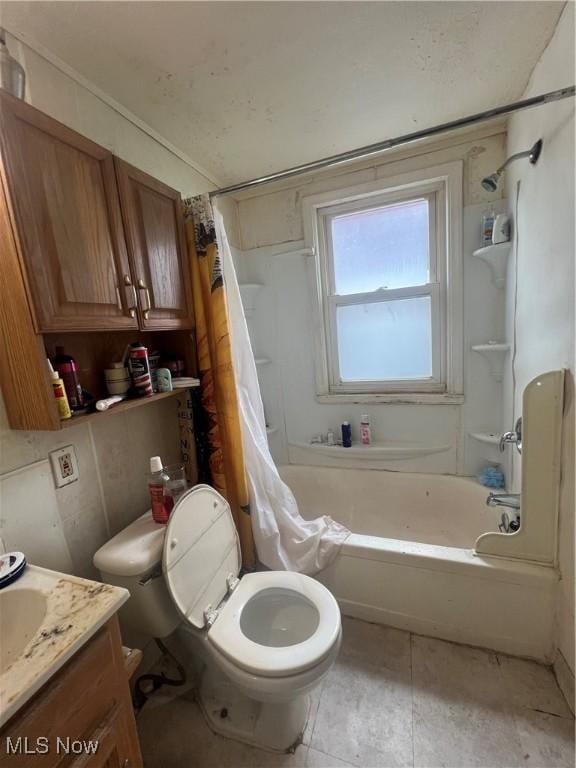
[184,195,256,570]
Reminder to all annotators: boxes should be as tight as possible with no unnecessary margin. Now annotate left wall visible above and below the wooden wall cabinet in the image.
[0,33,212,576]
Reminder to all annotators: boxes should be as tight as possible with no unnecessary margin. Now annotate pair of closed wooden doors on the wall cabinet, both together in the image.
[0,91,194,333]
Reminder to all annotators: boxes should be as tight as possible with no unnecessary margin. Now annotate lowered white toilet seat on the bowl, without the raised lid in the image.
[208,571,340,677]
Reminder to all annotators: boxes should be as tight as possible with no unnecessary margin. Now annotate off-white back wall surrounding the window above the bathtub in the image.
[236,126,505,474]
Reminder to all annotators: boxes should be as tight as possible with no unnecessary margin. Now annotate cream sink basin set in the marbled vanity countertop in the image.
[0,589,48,674]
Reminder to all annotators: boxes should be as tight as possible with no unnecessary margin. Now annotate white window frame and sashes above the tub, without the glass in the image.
[303,161,463,403]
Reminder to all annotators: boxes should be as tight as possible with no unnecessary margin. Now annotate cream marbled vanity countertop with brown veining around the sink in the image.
[0,565,130,726]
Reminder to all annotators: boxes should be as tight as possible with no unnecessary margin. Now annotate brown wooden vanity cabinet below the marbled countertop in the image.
[0,617,142,768]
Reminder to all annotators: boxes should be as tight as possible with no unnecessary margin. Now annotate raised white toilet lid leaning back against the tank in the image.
[162,485,241,629]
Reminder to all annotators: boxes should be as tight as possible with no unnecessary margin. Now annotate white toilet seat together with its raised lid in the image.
[162,485,341,677]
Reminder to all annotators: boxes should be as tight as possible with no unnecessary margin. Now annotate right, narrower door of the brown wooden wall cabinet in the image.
[115,158,194,329]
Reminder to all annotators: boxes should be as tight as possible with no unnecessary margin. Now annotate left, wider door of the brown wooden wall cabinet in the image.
[0,93,137,331]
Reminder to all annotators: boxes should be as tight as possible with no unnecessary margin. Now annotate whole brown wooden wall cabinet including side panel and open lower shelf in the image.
[0,89,196,430]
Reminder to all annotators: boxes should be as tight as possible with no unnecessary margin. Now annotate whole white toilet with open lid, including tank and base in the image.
[94,485,342,751]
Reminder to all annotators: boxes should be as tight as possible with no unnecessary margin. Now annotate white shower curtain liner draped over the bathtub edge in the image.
[215,210,350,574]
